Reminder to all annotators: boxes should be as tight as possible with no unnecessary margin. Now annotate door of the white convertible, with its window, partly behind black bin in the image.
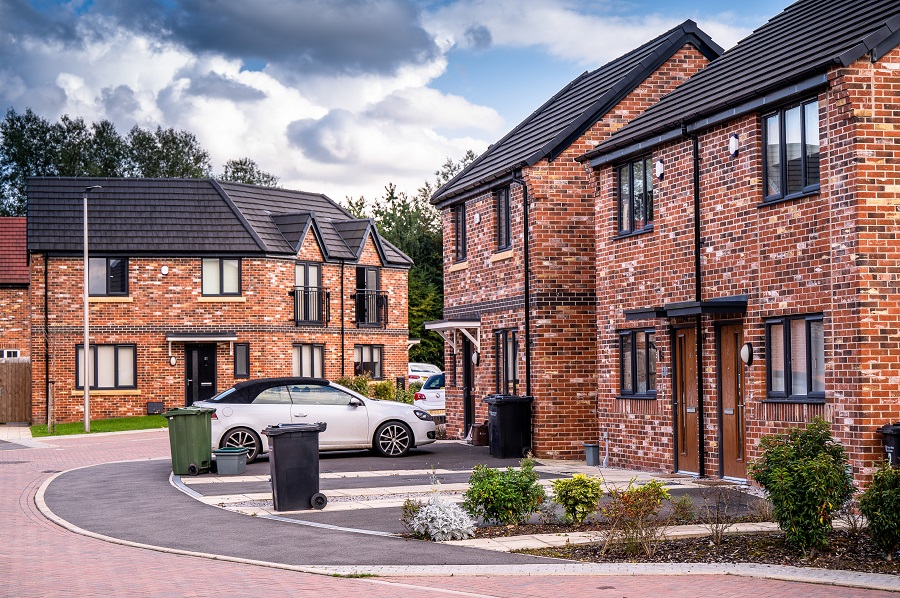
[290,384,372,448]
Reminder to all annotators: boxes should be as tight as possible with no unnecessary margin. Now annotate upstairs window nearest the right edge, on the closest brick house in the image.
[763,100,819,201]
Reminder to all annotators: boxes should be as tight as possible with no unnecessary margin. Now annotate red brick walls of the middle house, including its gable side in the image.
[443,45,708,458]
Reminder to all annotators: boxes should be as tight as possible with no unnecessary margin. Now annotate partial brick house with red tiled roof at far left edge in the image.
[0,218,31,359]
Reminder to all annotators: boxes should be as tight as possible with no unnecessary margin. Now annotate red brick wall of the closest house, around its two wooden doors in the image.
[595,49,900,488]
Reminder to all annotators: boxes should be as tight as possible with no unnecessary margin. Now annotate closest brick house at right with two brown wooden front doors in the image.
[582,0,900,480]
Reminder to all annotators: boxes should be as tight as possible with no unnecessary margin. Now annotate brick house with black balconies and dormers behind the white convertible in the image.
[28,178,411,421]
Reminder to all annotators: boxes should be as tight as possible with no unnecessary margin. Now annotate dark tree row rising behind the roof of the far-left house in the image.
[0,108,278,216]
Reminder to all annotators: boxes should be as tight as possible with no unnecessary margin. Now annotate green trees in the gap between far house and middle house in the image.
[346,150,475,365]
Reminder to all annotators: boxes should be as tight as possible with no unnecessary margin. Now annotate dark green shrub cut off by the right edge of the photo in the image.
[859,461,900,561]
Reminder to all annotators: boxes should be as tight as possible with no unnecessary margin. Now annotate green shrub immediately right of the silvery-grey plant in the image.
[463,459,545,525]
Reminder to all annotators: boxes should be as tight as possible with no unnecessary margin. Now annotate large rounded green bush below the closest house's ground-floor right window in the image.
[750,418,854,555]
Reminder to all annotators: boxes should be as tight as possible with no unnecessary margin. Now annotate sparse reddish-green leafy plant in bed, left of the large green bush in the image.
[601,479,670,556]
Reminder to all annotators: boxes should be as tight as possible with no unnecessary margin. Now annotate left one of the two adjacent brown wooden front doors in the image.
[673,328,700,473]
